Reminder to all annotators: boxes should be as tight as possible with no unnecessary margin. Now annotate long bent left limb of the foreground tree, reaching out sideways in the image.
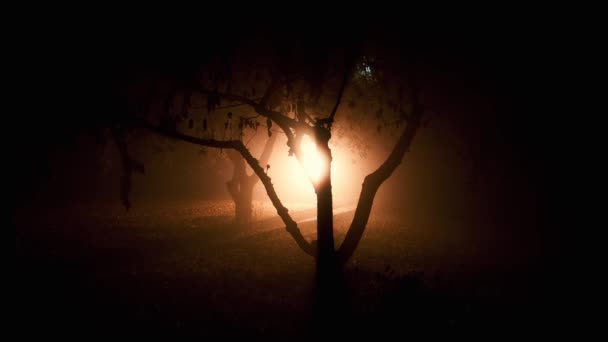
[137,120,316,257]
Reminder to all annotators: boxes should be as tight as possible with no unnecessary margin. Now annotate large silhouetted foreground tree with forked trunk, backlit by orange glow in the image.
[115,35,425,286]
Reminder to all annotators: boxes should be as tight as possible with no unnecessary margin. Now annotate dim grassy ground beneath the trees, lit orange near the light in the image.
[14,201,544,339]
